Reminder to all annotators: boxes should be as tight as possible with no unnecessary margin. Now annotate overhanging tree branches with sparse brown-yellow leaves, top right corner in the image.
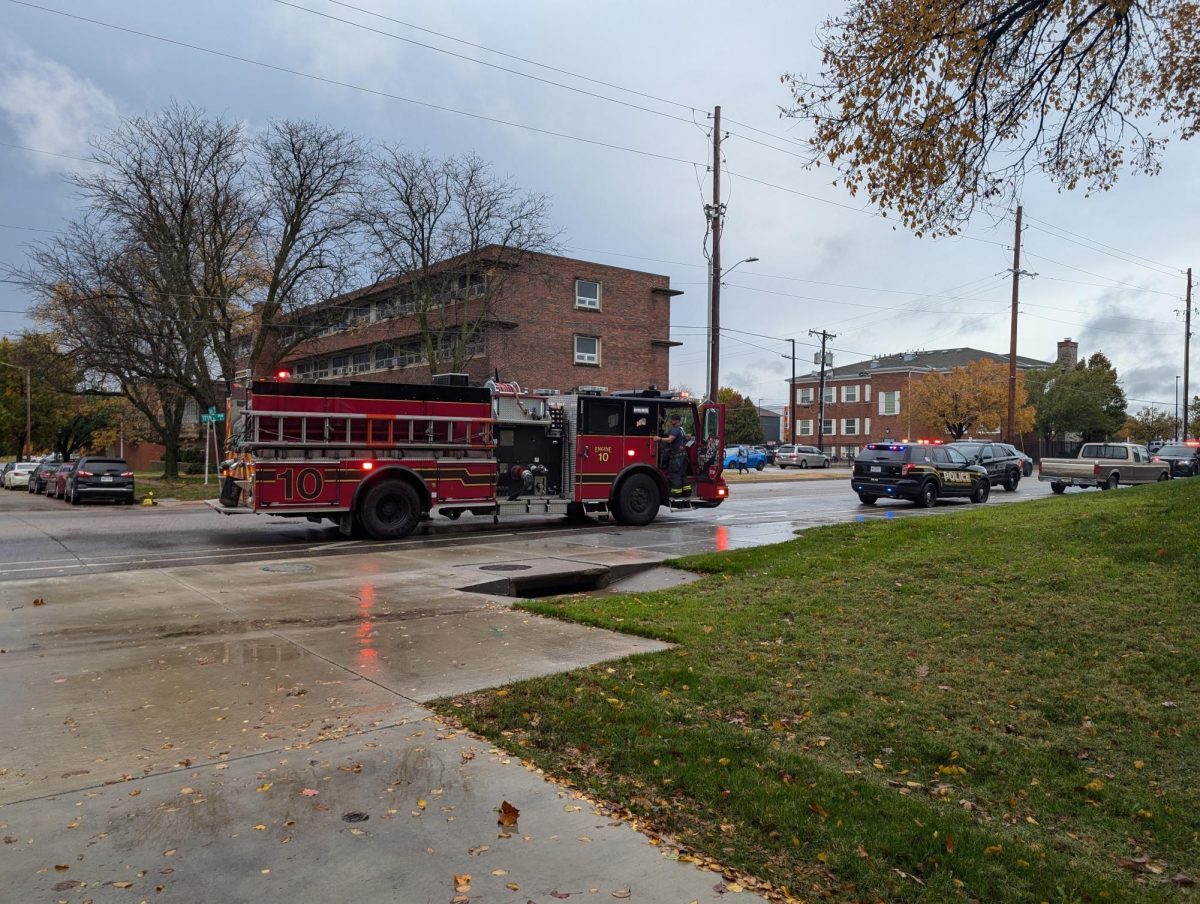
[782,0,1200,234]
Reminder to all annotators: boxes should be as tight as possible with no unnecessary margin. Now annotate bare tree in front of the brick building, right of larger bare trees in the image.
[360,148,558,372]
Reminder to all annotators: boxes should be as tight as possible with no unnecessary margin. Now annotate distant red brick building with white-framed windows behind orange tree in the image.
[785,339,1065,457]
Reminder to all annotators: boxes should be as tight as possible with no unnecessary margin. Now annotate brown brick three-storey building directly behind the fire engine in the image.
[273,249,683,391]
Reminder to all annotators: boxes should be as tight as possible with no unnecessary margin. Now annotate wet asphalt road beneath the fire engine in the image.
[0,475,1050,581]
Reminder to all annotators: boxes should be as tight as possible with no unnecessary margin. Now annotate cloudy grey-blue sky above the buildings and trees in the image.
[0,0,1200,409]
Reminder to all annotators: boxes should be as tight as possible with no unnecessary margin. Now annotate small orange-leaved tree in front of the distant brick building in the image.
[908,358,1033,439]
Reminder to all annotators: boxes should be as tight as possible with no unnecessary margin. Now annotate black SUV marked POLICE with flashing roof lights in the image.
[850,442,991,508]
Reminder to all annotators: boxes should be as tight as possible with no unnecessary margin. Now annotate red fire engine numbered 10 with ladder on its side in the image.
[212,381,728,540]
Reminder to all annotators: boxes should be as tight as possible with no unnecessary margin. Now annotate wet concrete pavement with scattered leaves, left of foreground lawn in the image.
[0,540,768,904]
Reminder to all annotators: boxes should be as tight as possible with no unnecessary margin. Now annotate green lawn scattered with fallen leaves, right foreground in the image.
[437,480,1200,902]
